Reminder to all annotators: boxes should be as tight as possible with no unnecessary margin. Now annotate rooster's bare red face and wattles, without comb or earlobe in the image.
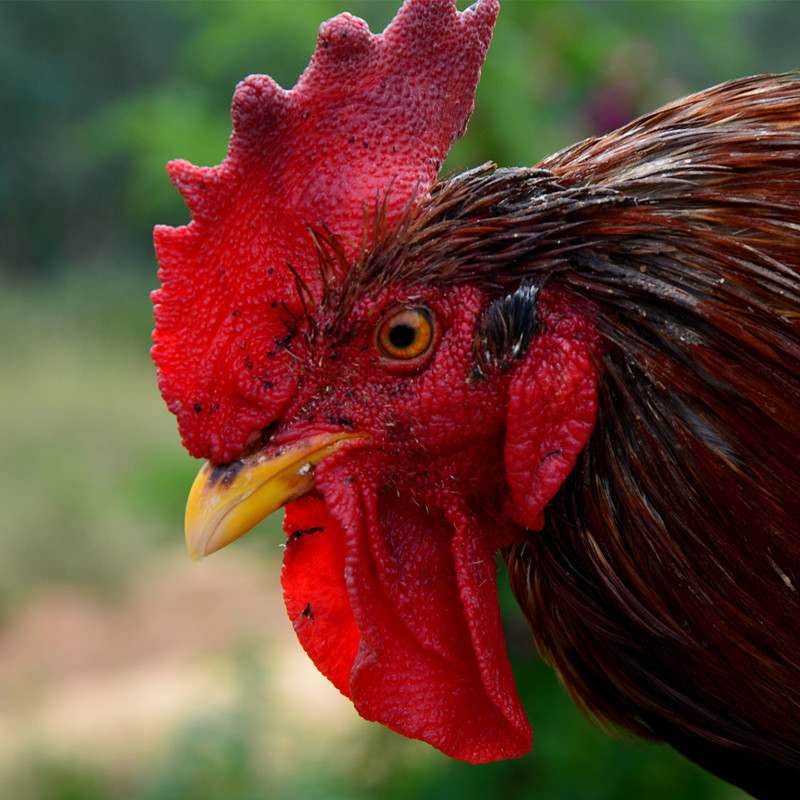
[276,287,531,761]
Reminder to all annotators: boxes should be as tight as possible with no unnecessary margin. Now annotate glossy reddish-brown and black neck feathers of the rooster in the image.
[348,76,800,797]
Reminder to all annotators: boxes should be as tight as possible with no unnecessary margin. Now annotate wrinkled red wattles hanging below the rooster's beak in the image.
[283,460,532,763]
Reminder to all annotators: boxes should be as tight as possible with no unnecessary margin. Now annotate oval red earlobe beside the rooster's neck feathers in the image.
[504,311,598,530]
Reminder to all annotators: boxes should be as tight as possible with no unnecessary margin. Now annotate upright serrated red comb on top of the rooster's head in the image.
[153,0,498,462]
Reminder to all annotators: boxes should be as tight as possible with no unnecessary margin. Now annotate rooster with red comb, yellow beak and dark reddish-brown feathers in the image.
[153,0,800,798]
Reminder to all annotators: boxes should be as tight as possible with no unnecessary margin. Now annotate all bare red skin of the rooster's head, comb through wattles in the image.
[153,0,597,762]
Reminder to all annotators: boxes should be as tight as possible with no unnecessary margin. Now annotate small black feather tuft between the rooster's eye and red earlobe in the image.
[475,280,542,372]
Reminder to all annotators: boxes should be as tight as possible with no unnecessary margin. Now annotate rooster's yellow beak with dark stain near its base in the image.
[186,433,369,561]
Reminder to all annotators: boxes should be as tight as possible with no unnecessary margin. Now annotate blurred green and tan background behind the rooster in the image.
[0,0,800,800]
